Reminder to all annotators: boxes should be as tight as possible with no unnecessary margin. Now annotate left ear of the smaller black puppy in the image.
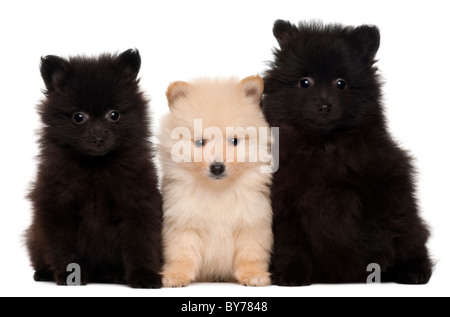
[40,55,70,91]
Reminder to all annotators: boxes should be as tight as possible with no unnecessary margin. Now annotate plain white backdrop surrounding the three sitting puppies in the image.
[0,0,450,296]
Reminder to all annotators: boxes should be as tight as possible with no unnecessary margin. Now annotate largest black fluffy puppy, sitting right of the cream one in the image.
[263,20,432,285]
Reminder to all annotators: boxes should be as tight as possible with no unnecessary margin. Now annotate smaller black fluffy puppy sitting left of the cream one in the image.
[26,50,162,288]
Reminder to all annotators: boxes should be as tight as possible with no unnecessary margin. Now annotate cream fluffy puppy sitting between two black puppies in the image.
[159,76,272,287]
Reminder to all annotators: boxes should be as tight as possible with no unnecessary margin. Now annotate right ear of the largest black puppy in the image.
[349,25,380,62]
